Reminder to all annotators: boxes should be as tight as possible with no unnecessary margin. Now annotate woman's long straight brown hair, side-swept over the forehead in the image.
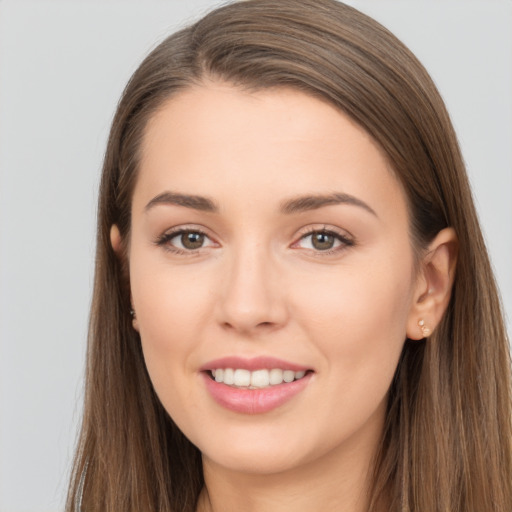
[67,0,512,512]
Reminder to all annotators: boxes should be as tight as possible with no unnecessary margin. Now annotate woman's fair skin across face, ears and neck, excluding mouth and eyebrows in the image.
[111,83,455,512]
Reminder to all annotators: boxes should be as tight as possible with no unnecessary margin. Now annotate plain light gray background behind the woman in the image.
[0,0,512,512]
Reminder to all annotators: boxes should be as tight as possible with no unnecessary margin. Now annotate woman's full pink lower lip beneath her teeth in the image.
[202,372,312,414]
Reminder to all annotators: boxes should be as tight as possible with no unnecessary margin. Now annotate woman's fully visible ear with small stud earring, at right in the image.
[407,228,458,340]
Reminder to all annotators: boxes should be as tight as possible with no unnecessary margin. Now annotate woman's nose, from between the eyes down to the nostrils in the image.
[217,247,289,336]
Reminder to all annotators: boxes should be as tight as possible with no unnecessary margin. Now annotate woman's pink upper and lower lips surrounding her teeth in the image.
[201,357,313,414]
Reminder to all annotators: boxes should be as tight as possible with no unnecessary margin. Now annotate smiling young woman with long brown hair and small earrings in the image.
[68,0,512,512]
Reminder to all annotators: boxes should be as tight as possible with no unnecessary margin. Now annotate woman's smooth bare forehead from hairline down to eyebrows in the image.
[134,83,404,220]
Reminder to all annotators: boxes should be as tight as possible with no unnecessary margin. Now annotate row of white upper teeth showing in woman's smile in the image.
[211,368,306,389]
